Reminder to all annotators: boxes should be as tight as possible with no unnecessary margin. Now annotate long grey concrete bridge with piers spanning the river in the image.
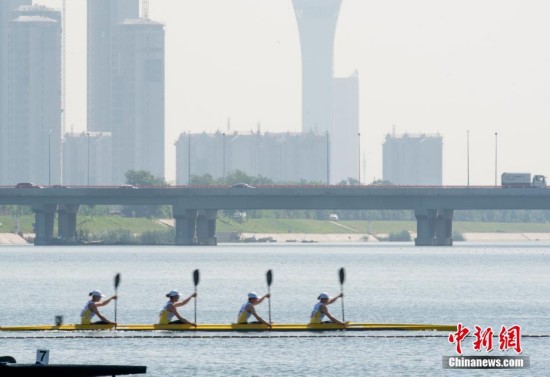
[0,186,550,246]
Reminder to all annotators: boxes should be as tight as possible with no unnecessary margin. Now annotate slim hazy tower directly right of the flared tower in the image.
[330,71,360,183]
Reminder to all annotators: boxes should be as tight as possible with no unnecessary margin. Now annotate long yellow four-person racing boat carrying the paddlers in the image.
[0,322,456,332]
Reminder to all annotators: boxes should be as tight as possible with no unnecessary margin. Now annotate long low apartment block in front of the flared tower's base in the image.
[176,132,329,185]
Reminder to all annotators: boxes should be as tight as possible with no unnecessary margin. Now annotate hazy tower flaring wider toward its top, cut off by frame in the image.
[292,0,342,135]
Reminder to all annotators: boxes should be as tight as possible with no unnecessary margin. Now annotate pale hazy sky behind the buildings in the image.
[35,0,550,185]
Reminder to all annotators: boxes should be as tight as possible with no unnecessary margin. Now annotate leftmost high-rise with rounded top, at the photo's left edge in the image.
[2,6,61,185]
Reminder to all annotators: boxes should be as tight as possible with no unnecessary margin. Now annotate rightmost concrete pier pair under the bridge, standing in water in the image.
[414,209,454,246]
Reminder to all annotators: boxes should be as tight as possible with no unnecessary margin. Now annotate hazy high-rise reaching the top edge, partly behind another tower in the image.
[87,0,139,132]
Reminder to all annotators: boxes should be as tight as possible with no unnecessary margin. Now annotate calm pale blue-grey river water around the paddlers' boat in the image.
[0,243,550,376]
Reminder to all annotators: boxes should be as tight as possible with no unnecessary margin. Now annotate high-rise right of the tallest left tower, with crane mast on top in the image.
[111,18,165,184]
